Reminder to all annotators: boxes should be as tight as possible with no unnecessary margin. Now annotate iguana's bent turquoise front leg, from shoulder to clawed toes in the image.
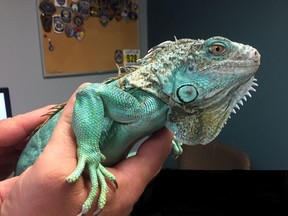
[66,83,151,214]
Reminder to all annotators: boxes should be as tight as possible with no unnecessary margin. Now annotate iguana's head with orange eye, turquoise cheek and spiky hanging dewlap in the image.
[134,37,260,144]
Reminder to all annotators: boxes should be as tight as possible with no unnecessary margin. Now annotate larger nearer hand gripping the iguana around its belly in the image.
[0,87,172,216]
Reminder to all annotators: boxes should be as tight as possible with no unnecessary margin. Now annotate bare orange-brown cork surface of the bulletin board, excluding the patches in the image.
[36,0,140,77]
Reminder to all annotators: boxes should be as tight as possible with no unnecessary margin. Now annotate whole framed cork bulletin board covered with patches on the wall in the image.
[36,0,140,77]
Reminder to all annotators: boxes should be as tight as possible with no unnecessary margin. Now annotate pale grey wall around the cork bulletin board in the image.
[0,0,147,115]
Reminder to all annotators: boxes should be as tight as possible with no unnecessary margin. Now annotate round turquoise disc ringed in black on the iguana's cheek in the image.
[176,84,198,104]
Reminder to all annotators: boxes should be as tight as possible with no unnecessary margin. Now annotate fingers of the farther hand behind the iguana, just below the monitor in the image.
[0,105,52,147]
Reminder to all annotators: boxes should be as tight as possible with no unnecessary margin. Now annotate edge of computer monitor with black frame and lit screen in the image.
[0,87,12,120]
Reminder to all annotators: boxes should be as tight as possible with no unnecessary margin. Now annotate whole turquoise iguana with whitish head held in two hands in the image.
[15,36,260,214]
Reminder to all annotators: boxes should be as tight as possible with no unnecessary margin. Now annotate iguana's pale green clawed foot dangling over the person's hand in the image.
[66,153,118,216]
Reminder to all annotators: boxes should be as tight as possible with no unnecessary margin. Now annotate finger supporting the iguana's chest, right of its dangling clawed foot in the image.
[101,128,173,216]
